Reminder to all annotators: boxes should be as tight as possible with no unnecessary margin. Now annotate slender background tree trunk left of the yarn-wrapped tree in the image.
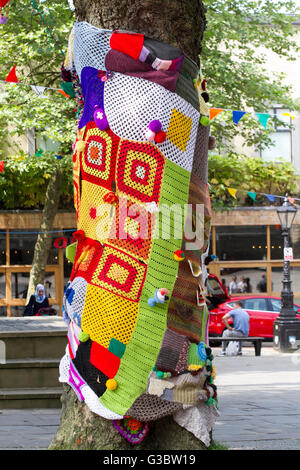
[27,165,62,303]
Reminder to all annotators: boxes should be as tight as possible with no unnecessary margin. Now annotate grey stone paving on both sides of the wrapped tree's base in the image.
[0,344,300,450]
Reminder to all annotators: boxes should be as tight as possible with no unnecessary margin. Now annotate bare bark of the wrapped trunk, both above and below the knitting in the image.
[50,0,206,450]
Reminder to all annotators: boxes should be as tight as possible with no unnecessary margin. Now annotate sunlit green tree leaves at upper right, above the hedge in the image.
[201,0,300,152]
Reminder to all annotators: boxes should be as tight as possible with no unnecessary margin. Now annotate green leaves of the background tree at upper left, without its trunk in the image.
[0,0,76,156]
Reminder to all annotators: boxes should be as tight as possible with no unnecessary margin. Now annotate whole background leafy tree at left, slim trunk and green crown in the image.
[0,0,75,298]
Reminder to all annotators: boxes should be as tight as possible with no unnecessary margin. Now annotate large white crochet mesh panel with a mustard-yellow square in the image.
[104,73,200,171]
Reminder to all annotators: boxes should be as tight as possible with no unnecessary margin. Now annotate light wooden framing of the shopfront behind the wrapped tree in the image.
[0,207,300,316]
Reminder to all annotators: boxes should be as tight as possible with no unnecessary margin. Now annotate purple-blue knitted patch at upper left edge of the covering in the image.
[78,67,105,129]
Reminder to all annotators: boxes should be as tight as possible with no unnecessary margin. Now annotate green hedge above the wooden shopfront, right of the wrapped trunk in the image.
[208,153,296,210]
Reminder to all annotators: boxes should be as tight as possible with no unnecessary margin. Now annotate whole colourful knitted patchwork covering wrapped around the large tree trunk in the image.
[60,22,216,442]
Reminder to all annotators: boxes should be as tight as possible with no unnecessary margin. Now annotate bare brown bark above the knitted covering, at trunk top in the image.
[74,0,206,62]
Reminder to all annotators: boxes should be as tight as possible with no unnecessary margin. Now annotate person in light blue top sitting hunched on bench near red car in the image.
[221,301,249,356]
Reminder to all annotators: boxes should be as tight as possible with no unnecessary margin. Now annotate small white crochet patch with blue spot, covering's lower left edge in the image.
[63,277,88,327]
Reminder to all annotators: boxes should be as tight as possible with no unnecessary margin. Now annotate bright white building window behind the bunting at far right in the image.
[261,108,293,162]
